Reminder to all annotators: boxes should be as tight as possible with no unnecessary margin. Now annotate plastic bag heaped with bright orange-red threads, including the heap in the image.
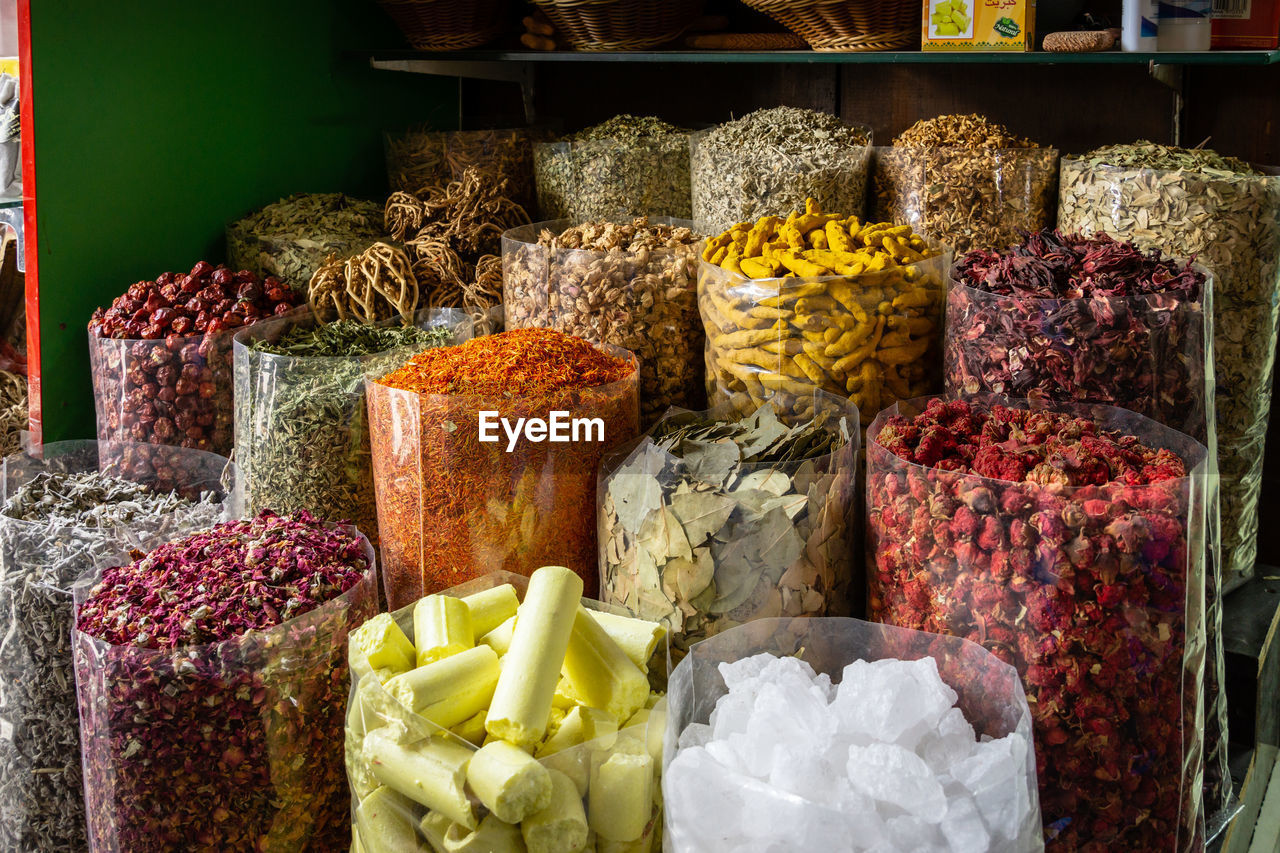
[367,329,639,608]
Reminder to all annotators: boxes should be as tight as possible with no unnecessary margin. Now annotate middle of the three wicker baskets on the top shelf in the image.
[532,0,703,50]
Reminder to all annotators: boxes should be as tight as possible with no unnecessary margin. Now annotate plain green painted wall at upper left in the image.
[31,0,457,441]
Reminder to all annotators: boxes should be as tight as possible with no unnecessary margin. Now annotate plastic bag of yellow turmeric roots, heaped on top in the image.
[698,199,951,425]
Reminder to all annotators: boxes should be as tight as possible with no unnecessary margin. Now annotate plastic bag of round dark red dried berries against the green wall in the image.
[88,261,302,488]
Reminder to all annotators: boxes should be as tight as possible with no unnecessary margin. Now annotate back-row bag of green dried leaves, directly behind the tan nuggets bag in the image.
[534,115,691,222]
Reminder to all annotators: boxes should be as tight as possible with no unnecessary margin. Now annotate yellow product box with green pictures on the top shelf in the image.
[920,0,1034,51]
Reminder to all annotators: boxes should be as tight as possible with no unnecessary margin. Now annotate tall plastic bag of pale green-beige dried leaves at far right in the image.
[1059,141,1280,590]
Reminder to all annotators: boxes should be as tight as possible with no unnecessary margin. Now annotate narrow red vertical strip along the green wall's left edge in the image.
[18,0,44,444]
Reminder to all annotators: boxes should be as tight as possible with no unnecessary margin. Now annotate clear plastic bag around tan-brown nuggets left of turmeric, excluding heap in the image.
[502,218,704,425]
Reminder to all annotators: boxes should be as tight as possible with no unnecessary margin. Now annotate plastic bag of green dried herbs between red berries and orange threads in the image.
[234,309,471,543]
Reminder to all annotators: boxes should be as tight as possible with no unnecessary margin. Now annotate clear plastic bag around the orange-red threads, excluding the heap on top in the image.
[366,346,640,610]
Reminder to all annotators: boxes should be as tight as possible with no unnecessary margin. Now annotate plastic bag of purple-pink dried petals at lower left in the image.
[72,512,378,853]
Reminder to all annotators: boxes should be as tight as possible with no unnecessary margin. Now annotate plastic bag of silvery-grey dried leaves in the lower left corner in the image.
[0,442,234,850]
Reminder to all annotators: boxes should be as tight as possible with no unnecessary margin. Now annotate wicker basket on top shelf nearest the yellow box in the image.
[742,0,920,50]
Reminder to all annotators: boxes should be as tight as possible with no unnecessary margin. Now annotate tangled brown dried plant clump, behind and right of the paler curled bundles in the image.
[385,168,529,334]
